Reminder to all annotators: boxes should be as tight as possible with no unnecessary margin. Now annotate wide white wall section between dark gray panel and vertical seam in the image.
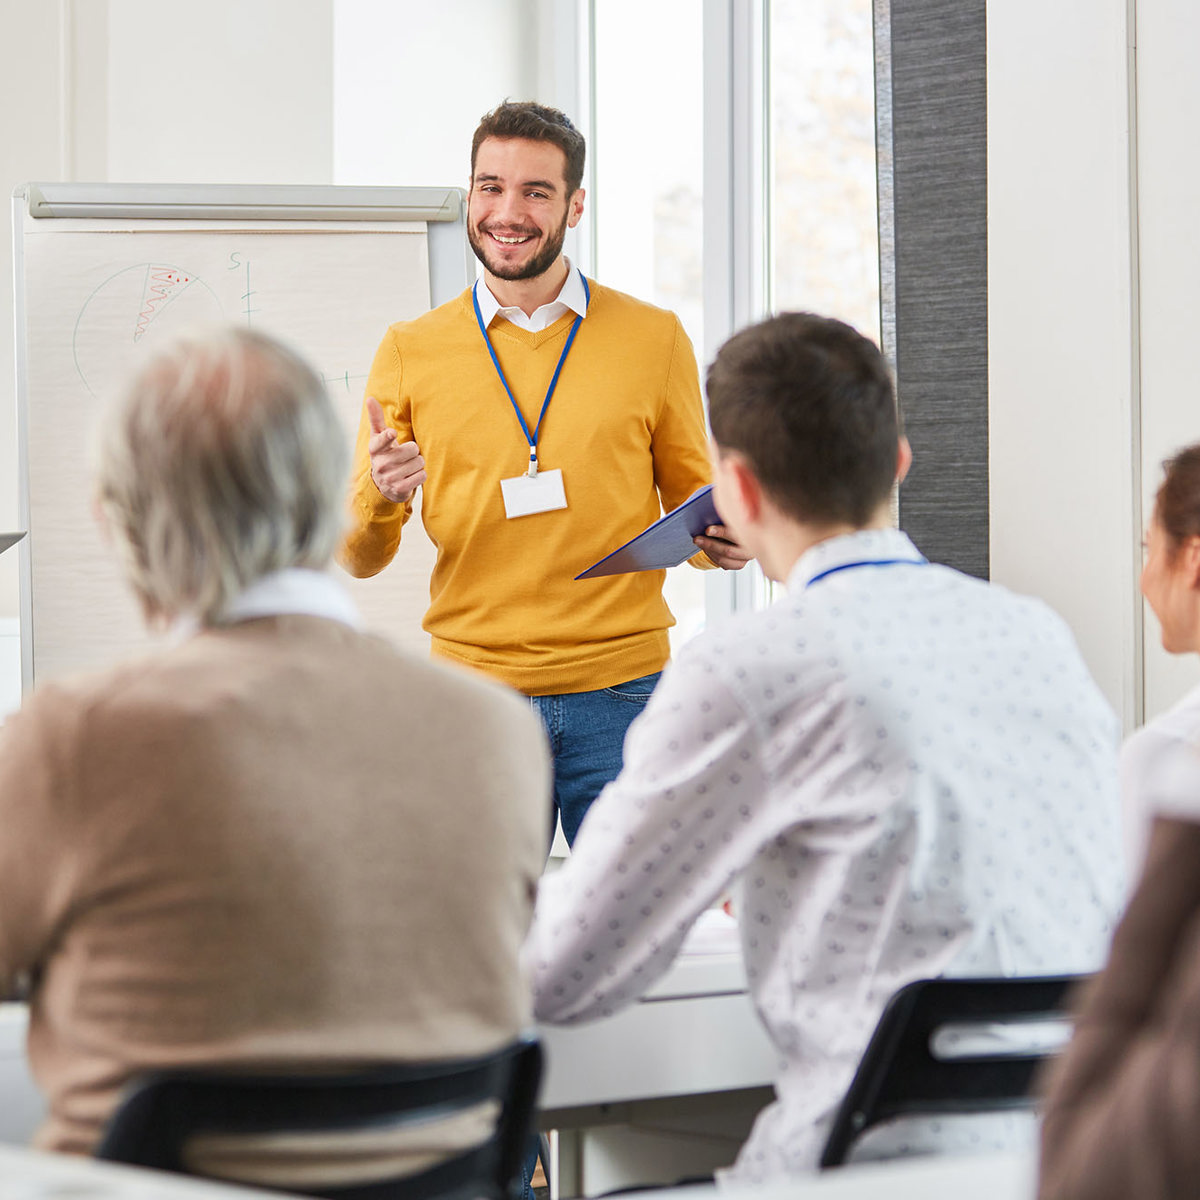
[988,0,1140,727]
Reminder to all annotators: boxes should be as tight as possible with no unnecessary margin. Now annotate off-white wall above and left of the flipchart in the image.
[0,0,332,638]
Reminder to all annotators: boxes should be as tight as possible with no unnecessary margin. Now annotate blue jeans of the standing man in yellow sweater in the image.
[529,671,662,846]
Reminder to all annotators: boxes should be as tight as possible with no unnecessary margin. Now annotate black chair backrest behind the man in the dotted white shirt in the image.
[821,976,1084,1168]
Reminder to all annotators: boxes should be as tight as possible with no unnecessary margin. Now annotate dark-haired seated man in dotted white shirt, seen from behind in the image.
[524,313,1121,1182]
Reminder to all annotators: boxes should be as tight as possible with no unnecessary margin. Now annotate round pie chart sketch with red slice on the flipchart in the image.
[72,263,224,398]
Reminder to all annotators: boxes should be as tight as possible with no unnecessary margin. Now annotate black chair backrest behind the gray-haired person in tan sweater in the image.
[96,1038,541,1200]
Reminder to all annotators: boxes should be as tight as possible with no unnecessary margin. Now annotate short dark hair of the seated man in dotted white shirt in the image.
[708,312,900,526]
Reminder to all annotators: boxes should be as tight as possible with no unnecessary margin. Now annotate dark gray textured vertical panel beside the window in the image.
[876,0,989,578]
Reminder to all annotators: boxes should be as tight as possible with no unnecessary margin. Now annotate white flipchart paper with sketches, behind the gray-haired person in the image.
[23,221,433,680]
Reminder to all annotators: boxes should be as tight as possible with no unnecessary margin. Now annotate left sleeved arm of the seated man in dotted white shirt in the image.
[523,652,766,1022]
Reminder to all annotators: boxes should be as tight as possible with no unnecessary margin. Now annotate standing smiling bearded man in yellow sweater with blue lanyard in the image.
[341,103,748,841]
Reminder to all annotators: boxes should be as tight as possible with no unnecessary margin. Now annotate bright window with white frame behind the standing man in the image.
[589,0,880,646]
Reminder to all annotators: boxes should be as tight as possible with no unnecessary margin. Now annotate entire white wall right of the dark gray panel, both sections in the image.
[988,0,1200,728]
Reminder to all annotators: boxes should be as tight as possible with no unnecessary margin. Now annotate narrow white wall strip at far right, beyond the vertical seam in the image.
[1136,0,1200,716]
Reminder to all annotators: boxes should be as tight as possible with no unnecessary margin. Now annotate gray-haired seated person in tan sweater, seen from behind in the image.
[0,330,550,1186]
